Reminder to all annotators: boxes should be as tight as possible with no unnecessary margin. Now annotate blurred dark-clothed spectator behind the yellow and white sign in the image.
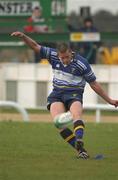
[79,18,100,64]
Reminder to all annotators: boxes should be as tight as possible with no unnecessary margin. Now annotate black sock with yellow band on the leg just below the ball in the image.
[60,128,76,148]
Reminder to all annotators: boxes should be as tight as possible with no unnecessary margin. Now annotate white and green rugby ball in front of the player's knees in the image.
[54,111,72,128]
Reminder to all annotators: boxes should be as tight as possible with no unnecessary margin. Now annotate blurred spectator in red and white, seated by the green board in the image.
[24,6,48,33]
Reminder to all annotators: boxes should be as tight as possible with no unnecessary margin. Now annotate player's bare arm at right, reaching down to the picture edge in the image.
[90,81,118,107]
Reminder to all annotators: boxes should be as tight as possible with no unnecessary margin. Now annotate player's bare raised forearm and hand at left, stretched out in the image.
[11,31,41,52]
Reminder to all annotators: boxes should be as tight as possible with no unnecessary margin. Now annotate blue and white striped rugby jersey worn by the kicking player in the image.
[40,46,96,92]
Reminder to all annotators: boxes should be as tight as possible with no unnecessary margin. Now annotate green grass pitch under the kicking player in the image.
[0,122,118,180]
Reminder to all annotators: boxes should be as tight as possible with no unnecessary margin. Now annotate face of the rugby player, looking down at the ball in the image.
[58,50,72,65]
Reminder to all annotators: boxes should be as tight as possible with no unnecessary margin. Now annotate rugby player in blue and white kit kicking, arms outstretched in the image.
[11,31,118,159]
